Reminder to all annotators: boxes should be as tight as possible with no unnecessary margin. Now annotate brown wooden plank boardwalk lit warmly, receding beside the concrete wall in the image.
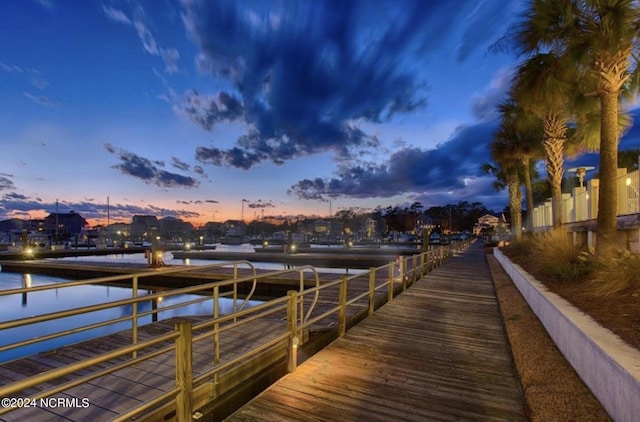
[226,244,526,422]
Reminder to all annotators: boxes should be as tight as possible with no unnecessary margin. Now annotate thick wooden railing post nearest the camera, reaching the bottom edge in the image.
[176,321,193,422]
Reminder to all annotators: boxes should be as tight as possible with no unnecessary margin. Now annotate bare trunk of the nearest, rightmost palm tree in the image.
[596,91,618,257]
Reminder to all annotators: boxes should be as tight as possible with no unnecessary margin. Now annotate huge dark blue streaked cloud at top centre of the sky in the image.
[181,0,500,169]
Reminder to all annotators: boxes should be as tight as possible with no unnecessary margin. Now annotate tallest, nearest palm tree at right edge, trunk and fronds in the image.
[512,0,640,256]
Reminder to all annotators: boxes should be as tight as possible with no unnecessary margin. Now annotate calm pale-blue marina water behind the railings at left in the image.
[0,245,355,362]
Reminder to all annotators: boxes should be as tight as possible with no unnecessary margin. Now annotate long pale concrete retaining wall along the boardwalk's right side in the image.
[494,248,640,422]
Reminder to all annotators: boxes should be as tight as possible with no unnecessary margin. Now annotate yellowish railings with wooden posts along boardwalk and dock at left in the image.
[0,241,471,422]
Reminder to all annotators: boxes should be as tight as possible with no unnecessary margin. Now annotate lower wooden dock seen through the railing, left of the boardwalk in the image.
[0,262,410,422]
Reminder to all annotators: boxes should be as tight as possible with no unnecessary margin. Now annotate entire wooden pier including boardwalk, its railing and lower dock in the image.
[0,241,522,421]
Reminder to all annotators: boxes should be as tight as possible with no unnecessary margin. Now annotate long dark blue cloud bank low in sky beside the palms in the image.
[288,121,498,200]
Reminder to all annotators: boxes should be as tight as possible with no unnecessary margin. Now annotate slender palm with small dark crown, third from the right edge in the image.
[498,97,544,231]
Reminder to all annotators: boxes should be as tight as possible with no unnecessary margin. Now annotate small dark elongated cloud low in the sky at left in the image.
[104,144,200,188]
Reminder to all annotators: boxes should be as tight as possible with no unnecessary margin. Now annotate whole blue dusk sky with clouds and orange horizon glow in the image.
[0,0,636,224]
